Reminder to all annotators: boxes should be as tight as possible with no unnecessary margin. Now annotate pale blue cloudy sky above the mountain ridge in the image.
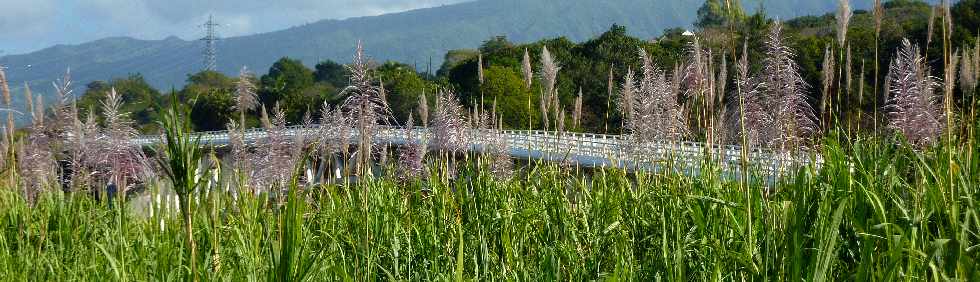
[0,0,467,56]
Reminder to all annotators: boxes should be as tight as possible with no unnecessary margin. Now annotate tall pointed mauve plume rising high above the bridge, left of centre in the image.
[341,41,393,170]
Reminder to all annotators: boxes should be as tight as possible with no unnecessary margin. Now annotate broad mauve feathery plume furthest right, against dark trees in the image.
[885,39,946,148]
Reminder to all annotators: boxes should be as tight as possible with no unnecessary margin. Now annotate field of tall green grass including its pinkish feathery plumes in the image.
[0,1,980,281]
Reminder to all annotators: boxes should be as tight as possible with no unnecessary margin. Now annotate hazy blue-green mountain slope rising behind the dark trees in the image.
[0,0,936,103]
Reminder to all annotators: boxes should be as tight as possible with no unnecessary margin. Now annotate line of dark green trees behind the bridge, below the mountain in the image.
[65,0,980,136]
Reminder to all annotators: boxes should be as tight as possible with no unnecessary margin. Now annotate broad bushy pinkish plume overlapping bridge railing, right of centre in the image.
[627,49,688,149]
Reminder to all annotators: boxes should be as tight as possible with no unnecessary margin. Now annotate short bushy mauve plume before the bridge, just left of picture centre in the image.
[429,89,467,153]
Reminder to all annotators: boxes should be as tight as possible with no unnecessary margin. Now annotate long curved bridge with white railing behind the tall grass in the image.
[133,126,823,179]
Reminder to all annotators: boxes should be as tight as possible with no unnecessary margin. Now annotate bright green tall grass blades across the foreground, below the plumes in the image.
[0,130,980,281]
